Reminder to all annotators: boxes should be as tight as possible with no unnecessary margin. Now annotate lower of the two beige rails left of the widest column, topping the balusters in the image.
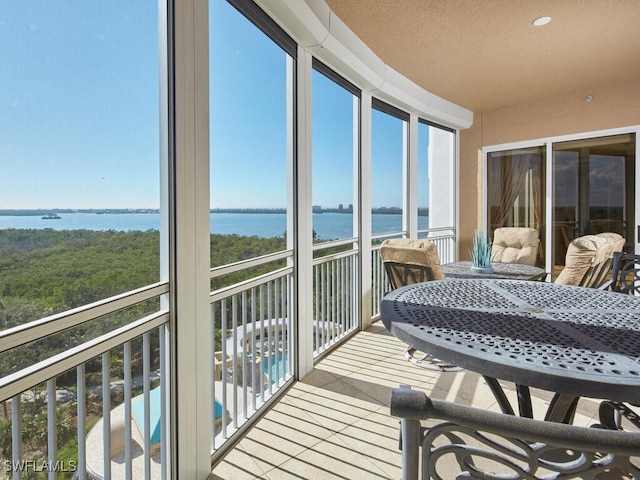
[0,310,169,403]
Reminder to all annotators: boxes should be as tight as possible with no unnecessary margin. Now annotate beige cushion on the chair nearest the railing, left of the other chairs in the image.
[380,238,445,280]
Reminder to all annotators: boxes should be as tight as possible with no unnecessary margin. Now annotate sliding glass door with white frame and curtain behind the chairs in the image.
[485,132,640,273]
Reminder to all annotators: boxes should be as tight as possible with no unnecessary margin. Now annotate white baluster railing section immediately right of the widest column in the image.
[210,262,294,454]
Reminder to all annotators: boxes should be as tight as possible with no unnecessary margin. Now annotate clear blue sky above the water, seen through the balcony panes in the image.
[0,0,426,209]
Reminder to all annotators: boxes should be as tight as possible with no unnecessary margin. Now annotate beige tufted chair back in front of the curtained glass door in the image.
[491,227,540,265]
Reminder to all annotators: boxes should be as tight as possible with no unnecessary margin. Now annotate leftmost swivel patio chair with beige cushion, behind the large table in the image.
[380,238,461,372]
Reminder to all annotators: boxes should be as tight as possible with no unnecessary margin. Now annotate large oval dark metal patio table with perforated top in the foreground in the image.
[381,279,640,422]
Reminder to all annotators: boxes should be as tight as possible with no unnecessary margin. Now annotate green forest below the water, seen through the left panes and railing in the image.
[0,229,286,470]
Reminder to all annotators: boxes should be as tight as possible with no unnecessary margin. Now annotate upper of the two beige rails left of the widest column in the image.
[0,282,169,352]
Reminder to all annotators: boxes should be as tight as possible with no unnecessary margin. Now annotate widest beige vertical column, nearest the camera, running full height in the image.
[167,0,213,480]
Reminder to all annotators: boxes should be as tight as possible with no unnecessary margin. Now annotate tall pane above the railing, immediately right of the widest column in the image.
[209,1,291,266]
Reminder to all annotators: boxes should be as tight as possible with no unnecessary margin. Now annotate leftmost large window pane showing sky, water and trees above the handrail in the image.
[0,0,160,328]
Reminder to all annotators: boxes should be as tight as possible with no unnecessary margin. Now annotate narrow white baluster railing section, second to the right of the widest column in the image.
[313,244,360,357]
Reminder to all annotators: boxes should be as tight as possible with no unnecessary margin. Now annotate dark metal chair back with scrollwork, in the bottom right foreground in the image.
[391,386,640,480]
